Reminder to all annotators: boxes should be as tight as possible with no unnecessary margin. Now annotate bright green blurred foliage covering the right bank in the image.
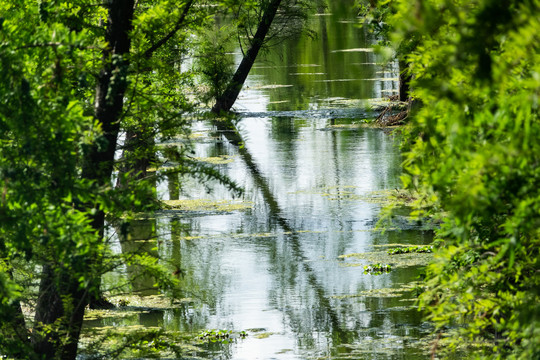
[389,0,540,359]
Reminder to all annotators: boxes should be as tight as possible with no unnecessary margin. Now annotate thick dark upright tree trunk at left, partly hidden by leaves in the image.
[32,0,134,360]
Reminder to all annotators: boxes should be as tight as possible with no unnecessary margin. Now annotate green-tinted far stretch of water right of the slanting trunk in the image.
[235,1,398,112]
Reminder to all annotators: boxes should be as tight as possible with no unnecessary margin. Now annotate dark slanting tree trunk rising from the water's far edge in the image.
[212,0,281,114]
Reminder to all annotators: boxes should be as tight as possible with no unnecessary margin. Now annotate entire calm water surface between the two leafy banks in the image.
[97,1,431,360]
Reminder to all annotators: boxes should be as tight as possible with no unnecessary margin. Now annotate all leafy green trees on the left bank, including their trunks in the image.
[0,0,239,359]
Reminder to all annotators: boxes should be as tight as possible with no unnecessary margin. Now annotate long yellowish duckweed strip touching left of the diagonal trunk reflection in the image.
[162,199,253,212]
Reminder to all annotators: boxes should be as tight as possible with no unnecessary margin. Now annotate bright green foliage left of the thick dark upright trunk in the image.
[0,2,105,358]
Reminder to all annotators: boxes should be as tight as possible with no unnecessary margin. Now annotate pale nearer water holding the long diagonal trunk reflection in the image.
[150,117,431,359]
